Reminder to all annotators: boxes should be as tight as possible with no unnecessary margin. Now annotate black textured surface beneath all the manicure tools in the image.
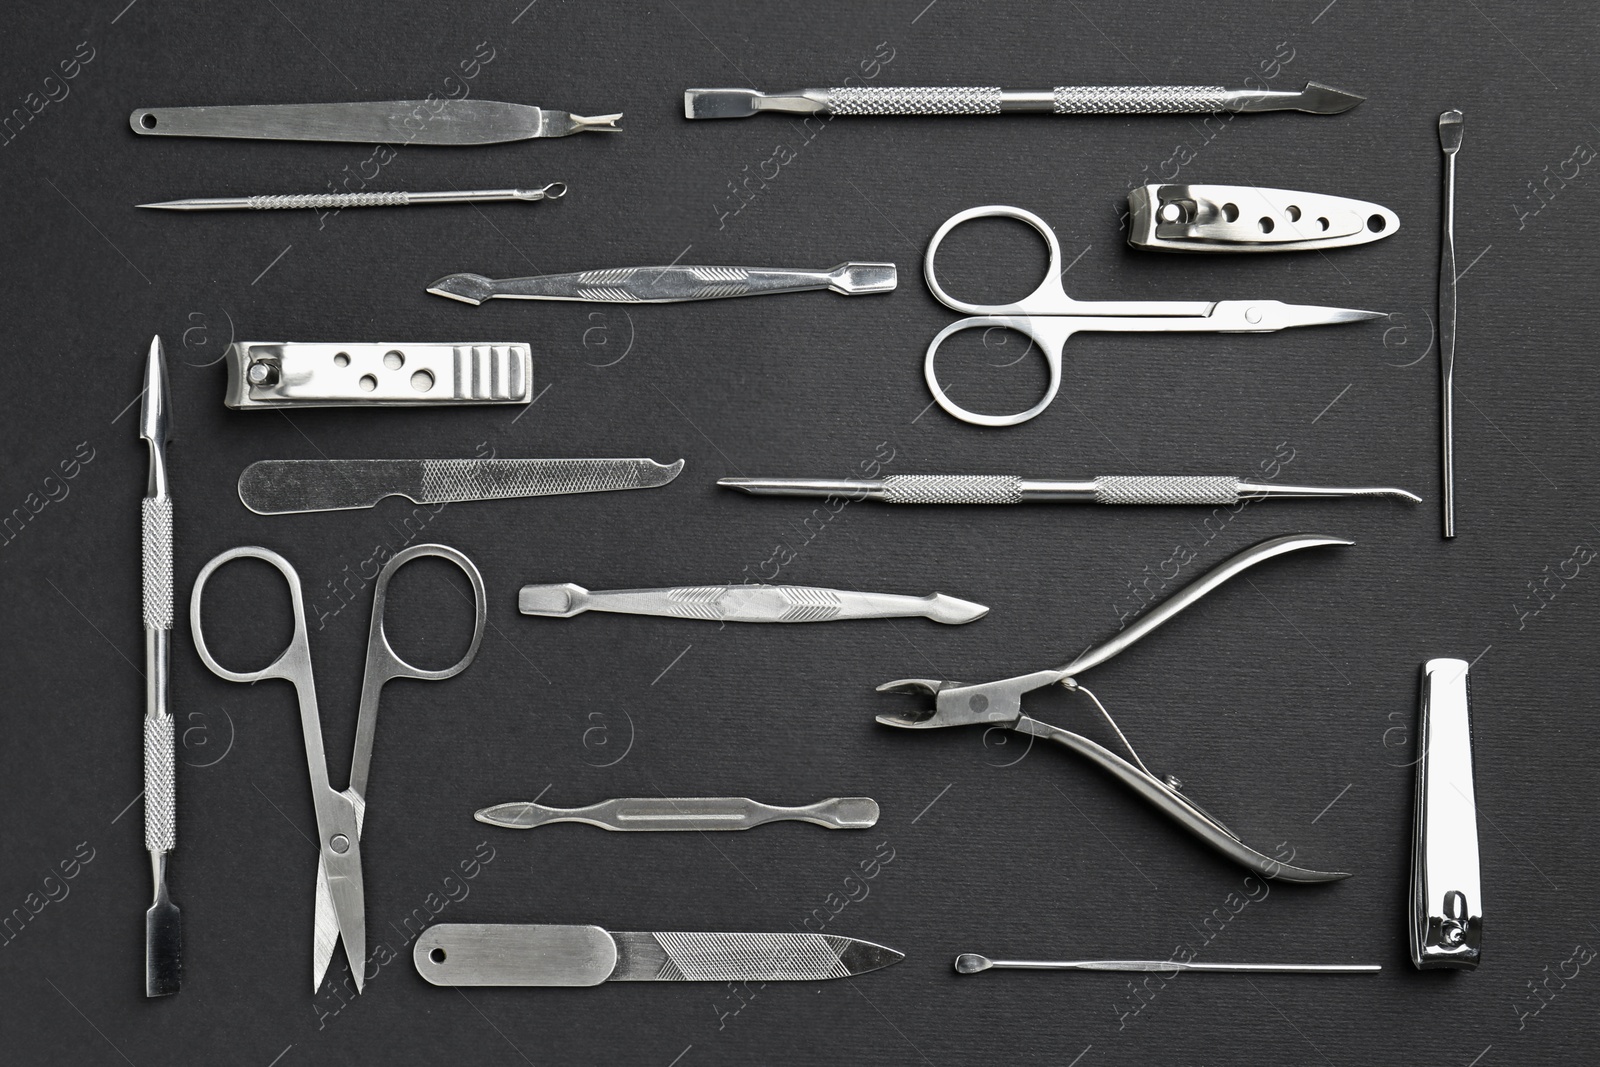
[0,0,1600,1067]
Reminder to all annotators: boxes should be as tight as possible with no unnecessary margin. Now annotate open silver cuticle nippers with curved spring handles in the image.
[877,534,1354,881]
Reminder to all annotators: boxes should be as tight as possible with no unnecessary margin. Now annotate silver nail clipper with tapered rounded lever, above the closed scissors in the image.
[1128,186,1400,251]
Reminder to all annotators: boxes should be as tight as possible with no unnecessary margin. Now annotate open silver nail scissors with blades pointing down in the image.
[189,544,488,993]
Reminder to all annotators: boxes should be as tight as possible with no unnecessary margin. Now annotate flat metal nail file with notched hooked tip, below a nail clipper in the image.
[238,459,683,515]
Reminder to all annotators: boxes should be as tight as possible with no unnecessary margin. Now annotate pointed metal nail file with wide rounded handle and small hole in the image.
[411,923,906,985]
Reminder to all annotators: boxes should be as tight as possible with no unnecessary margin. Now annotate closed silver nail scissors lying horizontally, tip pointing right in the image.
[923,205,1386,426]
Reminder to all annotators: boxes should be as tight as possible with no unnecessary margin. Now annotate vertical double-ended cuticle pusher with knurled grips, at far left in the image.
[139,336,184,997]
